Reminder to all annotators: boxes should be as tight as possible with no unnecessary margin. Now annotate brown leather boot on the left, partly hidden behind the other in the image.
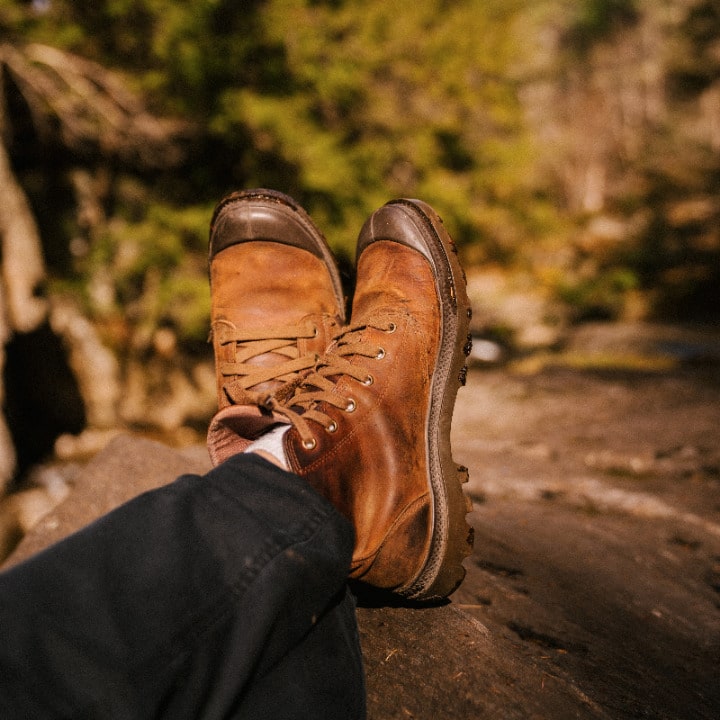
[208,190,345,464]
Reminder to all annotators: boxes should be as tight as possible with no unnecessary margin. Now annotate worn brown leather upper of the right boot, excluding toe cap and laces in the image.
[286,241,439,588]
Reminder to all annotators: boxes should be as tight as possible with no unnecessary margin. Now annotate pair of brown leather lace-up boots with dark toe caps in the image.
[208,190,472,600]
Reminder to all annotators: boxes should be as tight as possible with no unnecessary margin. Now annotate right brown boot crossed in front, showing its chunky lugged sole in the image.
[273,200,472,599]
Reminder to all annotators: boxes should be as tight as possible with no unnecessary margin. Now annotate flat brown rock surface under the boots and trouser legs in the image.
[1,367,720,720]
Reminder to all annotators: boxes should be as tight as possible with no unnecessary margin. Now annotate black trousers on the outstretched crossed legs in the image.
[0,454,365,720]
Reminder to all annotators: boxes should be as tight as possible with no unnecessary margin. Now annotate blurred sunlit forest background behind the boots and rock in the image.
[0,0,720,486]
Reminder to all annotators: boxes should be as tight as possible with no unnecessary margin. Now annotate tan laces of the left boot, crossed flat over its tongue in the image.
[211,320,319,404]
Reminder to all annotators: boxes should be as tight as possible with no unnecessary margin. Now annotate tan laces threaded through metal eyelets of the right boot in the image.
[261,320,397,450]
